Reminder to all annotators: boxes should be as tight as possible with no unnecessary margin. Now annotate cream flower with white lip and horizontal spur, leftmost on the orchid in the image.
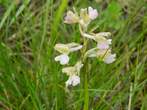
[54,42,83,65]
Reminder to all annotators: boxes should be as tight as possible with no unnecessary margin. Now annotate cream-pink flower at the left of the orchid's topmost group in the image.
[64,11,79,24]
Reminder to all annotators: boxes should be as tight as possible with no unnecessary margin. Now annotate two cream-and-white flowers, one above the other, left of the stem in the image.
[54,42,83,87]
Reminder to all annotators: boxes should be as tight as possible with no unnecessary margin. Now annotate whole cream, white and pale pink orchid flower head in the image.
[54,7,116,87]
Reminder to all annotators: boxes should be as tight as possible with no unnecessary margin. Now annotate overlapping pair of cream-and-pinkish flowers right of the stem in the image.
[83,32,116,64]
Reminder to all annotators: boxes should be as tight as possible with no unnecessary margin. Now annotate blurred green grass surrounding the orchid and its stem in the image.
[0,0,147,110]
